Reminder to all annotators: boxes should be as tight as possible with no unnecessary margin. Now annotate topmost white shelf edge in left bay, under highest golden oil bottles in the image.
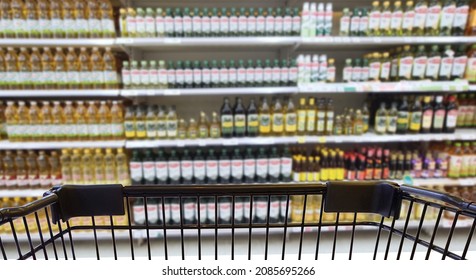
[0,38,116,47]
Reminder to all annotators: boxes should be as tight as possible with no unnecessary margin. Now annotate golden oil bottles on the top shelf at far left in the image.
[0,0,116,38]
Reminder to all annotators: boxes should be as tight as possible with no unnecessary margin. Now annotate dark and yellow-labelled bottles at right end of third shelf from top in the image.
[374,95,468,134]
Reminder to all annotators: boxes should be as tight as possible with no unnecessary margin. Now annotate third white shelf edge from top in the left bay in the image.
[0,140,125,150]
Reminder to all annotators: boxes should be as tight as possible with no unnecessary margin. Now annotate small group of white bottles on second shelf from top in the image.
[297,54,336,85]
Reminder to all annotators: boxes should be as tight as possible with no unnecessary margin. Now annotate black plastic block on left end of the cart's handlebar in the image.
[50,184,125,223]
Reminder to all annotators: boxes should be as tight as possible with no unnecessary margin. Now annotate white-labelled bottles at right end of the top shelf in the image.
[339,0,469,36]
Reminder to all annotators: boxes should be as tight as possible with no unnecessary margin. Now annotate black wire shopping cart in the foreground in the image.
[0,182,476,260]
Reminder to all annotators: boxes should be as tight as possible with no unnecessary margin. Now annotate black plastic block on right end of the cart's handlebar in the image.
[324,181,402,219]
